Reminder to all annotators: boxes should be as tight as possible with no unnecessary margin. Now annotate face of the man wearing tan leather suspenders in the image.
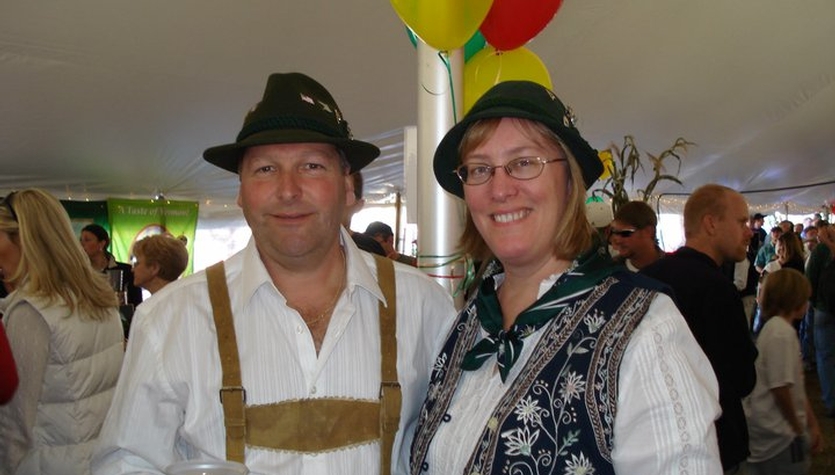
[238,143,354,266]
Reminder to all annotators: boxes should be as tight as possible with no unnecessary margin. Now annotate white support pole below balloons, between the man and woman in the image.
[417,41,466,308]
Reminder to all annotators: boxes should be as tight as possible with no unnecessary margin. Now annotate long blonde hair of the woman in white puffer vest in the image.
[0,189,119,320]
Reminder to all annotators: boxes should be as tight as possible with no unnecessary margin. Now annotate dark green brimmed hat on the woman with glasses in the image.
[433,81,603,198]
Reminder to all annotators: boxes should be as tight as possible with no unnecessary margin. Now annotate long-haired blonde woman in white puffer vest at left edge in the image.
[0,189,123,475]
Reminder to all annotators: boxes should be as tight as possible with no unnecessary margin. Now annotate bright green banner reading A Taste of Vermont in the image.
[107,199,197,275]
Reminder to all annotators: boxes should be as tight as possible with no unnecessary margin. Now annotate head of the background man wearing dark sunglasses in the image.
[609,201,664,272]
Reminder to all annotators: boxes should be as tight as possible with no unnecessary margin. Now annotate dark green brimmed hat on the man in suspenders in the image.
[203,73,380,173]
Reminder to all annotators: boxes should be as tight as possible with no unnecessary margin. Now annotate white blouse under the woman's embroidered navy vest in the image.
[422,275,722,475]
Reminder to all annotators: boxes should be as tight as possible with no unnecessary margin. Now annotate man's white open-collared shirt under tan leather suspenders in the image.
[93,230,455,475]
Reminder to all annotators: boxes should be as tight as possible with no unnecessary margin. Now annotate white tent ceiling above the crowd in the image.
[0,0,835,220]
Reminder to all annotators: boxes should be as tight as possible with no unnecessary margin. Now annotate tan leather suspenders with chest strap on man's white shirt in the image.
[206,255,402,475]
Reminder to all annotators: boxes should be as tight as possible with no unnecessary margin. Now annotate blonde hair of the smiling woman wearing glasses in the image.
[458,118,596,261]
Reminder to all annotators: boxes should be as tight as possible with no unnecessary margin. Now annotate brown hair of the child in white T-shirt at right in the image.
[759,267,812,320]
